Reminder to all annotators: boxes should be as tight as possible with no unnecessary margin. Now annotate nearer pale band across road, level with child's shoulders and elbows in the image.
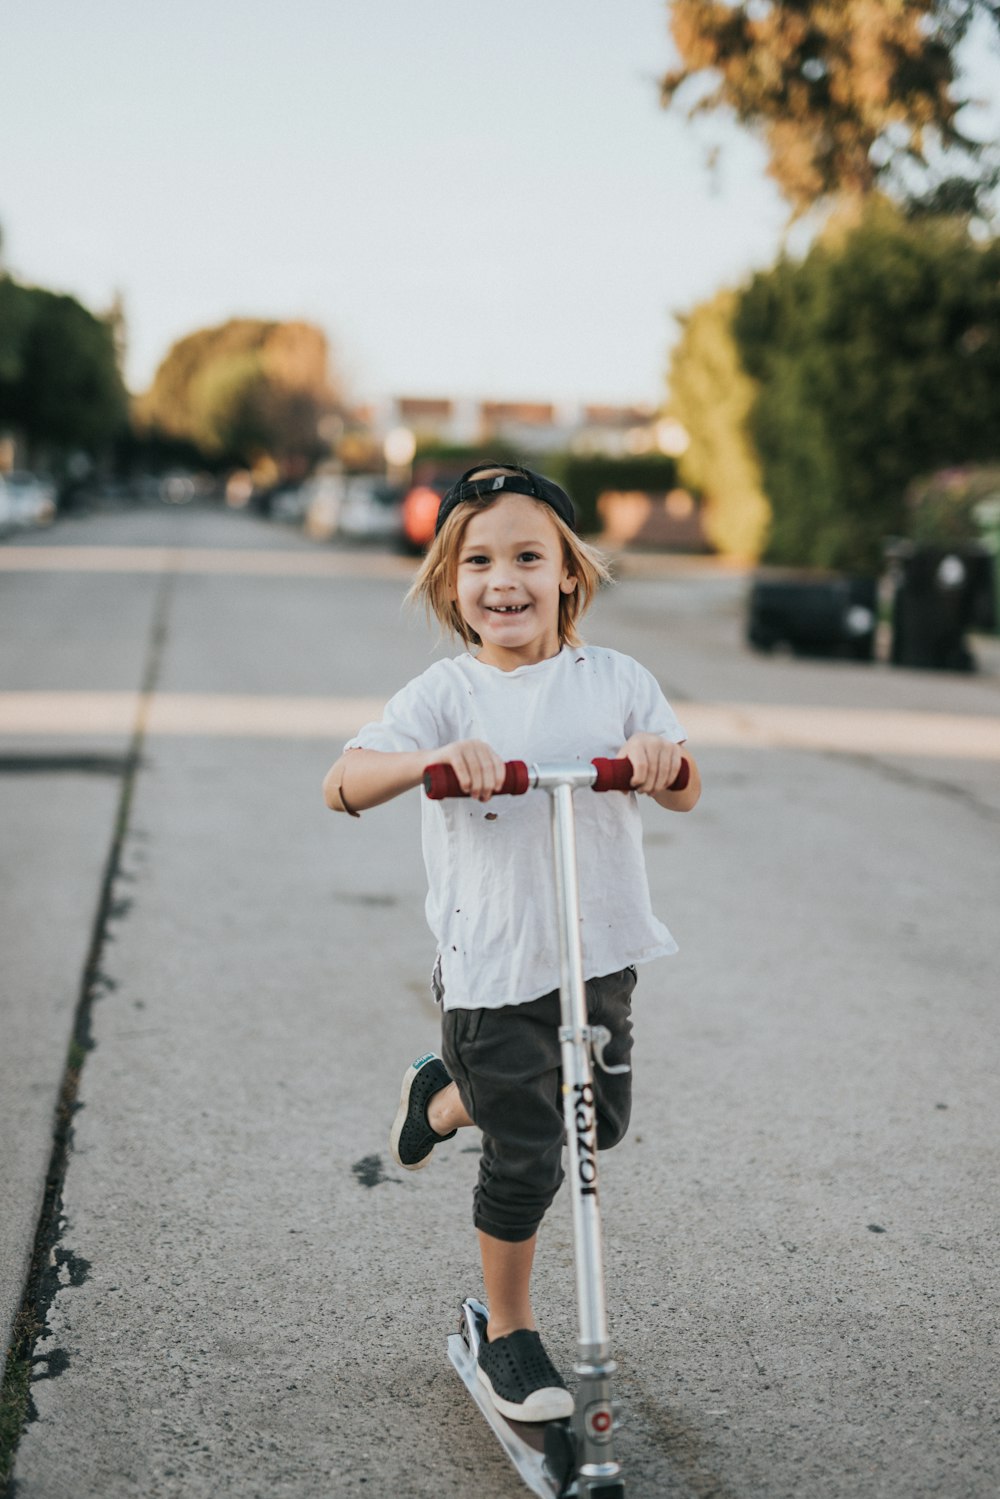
[0,693,1000,760]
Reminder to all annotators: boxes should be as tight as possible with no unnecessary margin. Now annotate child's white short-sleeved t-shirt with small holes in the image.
[346,646,687,1009]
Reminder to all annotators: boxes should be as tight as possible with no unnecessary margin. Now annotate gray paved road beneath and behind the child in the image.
[0,510,1000,1499]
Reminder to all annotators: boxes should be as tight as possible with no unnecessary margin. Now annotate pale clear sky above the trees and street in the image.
[0,0,995,405]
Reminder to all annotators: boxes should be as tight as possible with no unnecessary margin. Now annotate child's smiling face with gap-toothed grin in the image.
[451,495,576,672]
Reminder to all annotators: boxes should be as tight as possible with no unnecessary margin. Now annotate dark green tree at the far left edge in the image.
[0,276,127,462]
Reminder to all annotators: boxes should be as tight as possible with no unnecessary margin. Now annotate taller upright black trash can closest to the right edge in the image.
[886,541,994,672]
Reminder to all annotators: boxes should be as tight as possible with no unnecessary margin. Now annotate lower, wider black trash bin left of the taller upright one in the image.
[747,573,879,661]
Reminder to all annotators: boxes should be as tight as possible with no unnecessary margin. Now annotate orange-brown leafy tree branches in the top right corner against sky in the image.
[661,0,1000,214]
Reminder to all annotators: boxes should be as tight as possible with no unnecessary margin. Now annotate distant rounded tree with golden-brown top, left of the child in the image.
[136,318,337,465]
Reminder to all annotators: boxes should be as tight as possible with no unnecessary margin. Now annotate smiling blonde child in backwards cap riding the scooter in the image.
[324,463,700,1421]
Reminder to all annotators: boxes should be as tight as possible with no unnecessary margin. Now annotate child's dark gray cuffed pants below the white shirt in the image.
[441,968,636,1243]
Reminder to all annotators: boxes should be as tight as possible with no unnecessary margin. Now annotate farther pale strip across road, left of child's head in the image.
[0,546,418,580]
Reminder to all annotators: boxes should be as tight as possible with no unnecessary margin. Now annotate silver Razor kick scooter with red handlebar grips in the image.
[424,758,690,1499]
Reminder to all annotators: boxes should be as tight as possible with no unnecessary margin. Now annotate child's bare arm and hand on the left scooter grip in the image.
[322,739,504,815]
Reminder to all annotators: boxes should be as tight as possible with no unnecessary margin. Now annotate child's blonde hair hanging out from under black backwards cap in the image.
[406,468,612,646]
